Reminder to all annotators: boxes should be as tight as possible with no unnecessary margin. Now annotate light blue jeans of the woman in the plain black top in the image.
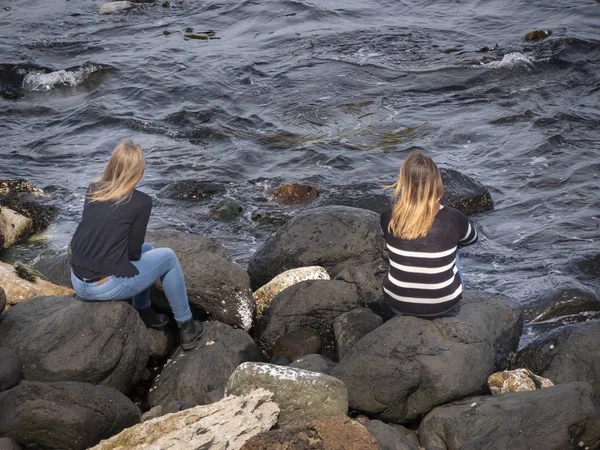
[71,242,192,323]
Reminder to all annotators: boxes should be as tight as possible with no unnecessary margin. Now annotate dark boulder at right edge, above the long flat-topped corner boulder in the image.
[514,322,600,396]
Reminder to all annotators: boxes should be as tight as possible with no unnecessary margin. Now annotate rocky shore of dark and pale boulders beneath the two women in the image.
[0,171,600,450]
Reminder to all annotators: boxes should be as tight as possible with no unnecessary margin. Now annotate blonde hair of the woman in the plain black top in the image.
[88,139,146,203]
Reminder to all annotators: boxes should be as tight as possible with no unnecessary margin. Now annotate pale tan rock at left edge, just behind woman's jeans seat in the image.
[0,262,73,307]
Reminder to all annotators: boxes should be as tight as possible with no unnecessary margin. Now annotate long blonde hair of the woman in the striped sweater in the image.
[387,150,444,240]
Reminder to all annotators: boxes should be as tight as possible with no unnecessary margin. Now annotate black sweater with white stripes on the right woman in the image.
[381,206,477,315]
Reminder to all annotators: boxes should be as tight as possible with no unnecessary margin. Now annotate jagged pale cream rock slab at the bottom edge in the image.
[92,389,279,450]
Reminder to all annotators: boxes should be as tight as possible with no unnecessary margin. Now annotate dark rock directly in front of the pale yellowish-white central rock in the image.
[255,280,364,359]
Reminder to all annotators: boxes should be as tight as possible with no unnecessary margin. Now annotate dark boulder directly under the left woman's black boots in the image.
[148,322,264,406]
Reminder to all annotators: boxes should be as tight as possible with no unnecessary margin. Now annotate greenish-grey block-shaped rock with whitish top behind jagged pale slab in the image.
[225,362,348,428]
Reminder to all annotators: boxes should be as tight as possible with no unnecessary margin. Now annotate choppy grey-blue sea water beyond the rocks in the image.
[0,0,600,301]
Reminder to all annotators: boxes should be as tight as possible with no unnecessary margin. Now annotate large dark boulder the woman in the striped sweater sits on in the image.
[331,292,522,423]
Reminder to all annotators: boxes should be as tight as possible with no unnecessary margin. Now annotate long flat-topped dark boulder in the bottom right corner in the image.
[419,383,600,450]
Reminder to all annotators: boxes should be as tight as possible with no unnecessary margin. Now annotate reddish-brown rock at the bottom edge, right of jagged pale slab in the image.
[240,415,380,450]
